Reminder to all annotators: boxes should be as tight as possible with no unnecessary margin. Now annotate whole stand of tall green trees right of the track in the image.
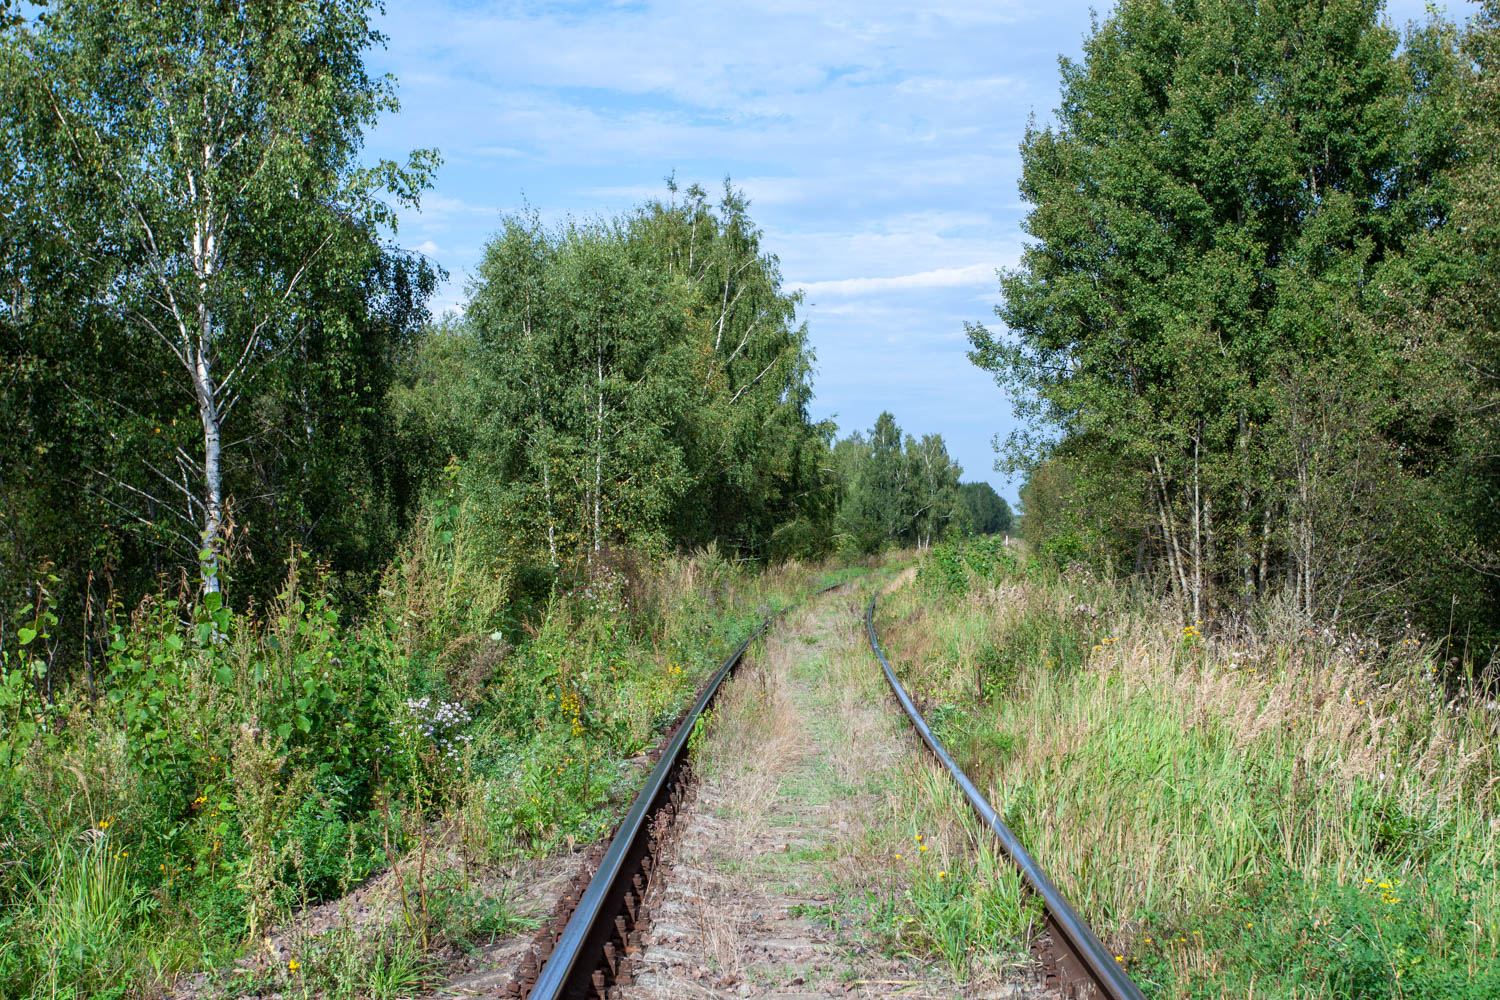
[969,0,1500,656]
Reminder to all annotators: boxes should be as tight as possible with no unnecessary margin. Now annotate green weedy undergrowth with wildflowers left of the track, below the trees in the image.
[0,523,870,999]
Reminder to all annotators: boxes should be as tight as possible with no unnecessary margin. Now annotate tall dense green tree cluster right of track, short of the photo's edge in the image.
[969,0,1457,629]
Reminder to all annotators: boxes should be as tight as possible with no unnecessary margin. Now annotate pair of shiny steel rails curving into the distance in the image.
[507,583,1143,1000]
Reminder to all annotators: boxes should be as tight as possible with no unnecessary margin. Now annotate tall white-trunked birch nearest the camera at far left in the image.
[8,0,437,592]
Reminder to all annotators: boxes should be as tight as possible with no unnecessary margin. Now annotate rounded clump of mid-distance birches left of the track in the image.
[450,186,830,568]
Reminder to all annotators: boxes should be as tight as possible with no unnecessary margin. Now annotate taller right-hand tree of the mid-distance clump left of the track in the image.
[627,178,833,558]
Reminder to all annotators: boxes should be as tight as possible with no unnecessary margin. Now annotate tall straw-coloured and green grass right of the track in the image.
[882,563,1500,996]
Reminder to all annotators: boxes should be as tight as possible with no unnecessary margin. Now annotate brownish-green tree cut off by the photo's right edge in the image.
[1379,0,1500,649]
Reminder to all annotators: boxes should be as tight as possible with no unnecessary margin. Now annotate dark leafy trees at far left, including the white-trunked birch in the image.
[0,0,437,687]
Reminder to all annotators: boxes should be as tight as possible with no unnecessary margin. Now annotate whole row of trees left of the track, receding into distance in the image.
[0,0,1008,691]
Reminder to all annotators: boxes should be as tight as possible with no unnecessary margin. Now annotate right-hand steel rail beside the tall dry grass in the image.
[864,595,1146,1000]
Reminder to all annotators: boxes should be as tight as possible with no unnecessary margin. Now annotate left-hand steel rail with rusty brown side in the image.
[527,580,849,1000]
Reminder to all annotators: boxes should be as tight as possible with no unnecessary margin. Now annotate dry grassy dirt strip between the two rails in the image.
[623,594,1049,1000]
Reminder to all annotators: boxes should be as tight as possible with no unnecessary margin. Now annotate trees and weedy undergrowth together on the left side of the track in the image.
[0,0,966,999]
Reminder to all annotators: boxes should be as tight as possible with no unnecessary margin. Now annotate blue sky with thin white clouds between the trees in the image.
[360,0,1440,501]
